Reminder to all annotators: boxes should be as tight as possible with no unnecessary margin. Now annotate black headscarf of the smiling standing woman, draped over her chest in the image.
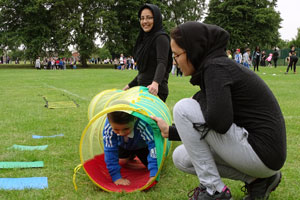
[134,4,169,72]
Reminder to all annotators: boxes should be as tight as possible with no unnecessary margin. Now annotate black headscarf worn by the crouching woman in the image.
[178,22,229,85]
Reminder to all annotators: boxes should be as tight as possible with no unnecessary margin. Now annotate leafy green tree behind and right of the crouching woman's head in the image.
[204,0,282,49]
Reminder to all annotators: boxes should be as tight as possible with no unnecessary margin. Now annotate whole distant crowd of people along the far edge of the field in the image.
[0,46,298,77]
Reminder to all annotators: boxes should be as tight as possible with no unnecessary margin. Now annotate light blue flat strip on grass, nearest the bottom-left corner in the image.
[0,177,48,190]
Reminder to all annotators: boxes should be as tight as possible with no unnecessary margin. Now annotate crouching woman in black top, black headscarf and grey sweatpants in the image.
[152,22,286,200]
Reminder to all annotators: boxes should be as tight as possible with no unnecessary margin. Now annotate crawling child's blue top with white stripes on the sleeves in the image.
[103,119,158,182]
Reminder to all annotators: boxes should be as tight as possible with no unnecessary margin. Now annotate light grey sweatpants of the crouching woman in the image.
[173,98,276,194]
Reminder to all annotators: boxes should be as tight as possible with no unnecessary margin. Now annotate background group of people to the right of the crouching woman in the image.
[226,46,298,74]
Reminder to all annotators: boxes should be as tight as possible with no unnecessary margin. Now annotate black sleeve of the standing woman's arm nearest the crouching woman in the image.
[153,35,170,84]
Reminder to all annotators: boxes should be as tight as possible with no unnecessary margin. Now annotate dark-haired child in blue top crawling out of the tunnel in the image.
[103,111,157,185]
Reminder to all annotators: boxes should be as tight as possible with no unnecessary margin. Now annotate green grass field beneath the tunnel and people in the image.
[0,67,300,200]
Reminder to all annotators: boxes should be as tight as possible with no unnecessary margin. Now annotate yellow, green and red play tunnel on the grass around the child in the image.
[73,87,171,192]
